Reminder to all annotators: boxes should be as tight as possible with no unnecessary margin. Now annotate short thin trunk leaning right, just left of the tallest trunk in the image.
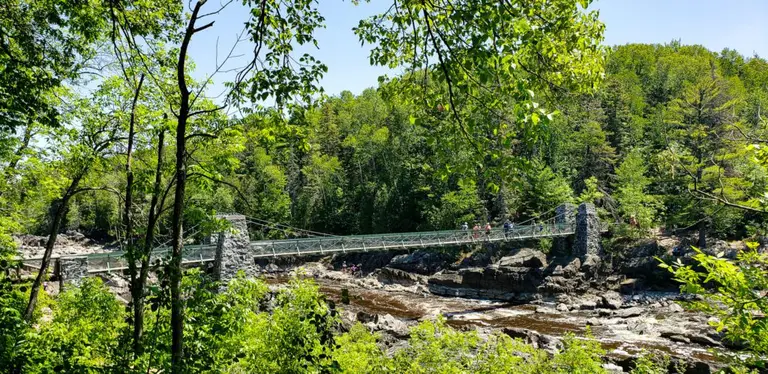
[131,130,165,355]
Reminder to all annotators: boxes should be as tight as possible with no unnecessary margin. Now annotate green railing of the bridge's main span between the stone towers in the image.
[246,224,574,257]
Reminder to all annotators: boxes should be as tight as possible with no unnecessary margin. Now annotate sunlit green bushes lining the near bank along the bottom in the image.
[2,272,628,373]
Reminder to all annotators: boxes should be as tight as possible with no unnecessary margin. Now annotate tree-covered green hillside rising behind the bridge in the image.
[7,42,768,244]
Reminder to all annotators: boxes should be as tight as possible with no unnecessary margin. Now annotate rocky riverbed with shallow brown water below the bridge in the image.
[268,263,729,373]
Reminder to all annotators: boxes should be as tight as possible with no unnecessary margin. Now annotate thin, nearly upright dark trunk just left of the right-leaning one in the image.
[123,74,144,355]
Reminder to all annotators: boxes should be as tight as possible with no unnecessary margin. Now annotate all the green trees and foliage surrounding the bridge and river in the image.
[0,0,768,373]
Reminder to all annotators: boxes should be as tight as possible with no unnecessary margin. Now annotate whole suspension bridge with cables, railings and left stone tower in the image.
[16,204,605,282]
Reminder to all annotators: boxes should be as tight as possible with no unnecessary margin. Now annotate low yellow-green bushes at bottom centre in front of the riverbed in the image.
[334,318,604,374]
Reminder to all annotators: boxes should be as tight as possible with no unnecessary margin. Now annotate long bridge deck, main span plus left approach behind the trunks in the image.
[23,224,574,274]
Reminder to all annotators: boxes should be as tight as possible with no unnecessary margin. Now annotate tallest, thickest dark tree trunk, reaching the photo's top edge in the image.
[169,0,204,374]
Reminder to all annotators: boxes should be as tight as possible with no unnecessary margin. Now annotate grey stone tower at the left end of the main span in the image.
[213,214,258,284]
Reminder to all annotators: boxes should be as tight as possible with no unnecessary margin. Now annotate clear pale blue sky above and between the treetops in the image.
[190,0,768,96]
